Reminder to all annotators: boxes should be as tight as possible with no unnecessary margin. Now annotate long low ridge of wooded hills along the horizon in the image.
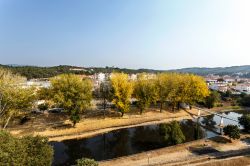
[0,64,250,79]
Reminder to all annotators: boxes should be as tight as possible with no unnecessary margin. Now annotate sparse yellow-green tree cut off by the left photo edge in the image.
[0,68,36,129]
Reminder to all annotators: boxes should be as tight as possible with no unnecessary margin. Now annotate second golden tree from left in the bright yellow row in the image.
[134,74,156,114]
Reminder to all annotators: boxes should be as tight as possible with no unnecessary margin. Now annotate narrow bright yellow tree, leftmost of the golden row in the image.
[110,73,133,116]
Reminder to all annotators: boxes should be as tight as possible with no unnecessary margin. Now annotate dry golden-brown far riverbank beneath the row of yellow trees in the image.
[9,107,244,141]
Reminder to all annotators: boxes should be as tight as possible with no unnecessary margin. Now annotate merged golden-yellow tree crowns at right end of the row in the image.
[156,73,209,111]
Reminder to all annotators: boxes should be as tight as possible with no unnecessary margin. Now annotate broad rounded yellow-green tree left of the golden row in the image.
[50,74,92,126]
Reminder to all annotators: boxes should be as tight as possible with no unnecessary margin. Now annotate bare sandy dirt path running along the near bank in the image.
[99,137,250,166]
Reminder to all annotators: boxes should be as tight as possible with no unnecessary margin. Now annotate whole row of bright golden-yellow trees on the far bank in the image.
[108,73,209,115]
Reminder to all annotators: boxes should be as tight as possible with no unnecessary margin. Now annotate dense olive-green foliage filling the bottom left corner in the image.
[0,131,53,166]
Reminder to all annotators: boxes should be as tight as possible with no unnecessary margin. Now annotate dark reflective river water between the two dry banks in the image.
[50,111,246,165]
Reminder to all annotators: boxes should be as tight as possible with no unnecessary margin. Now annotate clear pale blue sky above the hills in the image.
[0,0,250,69]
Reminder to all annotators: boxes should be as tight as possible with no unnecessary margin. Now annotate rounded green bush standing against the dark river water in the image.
[160,121,185,145]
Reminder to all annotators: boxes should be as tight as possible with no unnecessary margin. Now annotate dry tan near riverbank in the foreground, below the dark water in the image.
[99,135,250,166]
